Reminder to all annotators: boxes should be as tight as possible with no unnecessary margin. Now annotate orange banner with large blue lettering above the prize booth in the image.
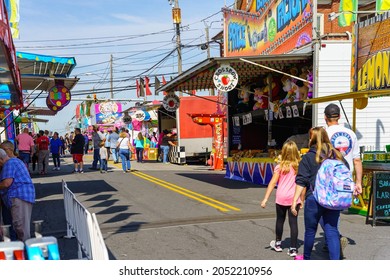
[223,0,313,57]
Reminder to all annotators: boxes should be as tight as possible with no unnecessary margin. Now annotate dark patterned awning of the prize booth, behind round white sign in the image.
[157,53,312,92]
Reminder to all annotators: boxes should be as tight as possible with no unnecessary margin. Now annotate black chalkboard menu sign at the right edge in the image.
[372,171,390,226]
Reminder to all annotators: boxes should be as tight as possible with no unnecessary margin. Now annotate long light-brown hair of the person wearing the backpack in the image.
[309,127,343,163]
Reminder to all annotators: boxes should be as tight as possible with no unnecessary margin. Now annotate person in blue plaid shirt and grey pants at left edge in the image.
[0,149,35,241]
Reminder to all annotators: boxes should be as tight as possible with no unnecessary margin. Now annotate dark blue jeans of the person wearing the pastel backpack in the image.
[303,195,340,260]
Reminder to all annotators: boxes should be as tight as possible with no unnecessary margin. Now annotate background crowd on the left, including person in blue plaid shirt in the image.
[0,125,175,241]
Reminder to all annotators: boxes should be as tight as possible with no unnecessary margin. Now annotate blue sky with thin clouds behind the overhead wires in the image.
[14,0,234,134]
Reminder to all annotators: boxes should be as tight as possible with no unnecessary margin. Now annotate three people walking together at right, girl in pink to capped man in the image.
[260,103,363,260]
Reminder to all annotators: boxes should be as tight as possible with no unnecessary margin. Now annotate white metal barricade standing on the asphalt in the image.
[62,180,109,260]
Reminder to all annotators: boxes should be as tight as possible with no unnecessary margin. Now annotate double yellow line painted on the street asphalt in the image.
[132,171,241,212]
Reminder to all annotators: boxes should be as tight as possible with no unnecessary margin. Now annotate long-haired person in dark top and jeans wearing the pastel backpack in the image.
[291,127,343,260]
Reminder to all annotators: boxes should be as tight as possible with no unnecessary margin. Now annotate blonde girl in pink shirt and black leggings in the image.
[261,141,300,257]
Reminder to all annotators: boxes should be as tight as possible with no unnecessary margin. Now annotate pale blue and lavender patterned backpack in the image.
[313,159,355,210]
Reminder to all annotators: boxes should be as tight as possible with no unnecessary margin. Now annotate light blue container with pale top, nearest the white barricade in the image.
[25,236,60,260]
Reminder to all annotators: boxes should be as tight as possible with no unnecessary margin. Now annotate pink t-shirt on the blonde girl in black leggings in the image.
[274,164,301,206]
